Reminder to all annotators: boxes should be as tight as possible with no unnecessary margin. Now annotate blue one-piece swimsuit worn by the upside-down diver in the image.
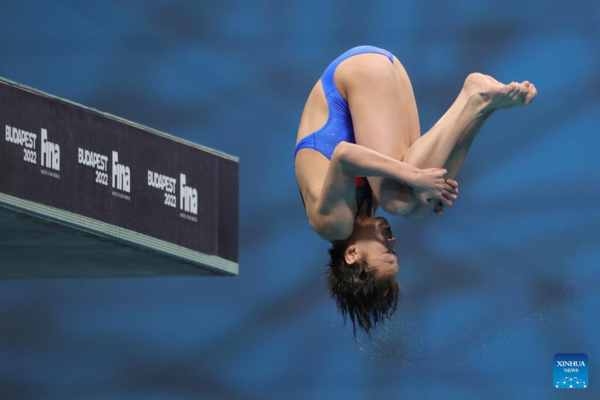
[294,46,394,216]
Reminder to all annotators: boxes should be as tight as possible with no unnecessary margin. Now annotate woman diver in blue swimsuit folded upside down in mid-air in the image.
[294,46,537,336]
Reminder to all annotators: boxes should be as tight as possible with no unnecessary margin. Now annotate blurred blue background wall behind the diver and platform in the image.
[0,0,600,399]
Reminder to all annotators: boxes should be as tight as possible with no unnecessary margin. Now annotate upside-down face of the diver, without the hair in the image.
[346,217,398,276]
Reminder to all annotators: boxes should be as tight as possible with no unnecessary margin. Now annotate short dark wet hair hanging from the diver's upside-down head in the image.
[326,241,400,339]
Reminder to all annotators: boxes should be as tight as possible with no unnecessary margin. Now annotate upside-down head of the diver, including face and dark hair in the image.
[327,215,400,337]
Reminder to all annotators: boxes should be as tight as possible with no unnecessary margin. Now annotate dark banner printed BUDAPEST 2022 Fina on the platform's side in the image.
[0,80,238,262]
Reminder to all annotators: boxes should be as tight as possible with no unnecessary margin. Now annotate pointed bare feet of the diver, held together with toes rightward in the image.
[463,72,537,112]
